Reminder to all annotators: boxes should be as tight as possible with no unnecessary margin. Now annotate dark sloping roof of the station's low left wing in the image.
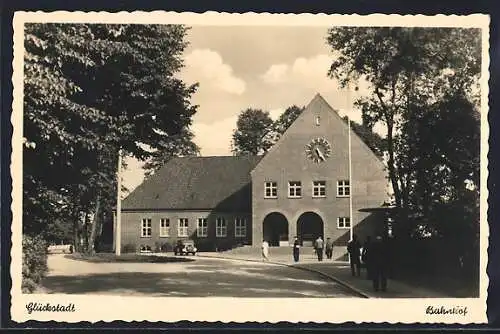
[122,156,261,212]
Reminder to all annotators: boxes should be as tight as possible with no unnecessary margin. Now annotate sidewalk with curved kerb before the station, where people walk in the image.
[198,252,453,298]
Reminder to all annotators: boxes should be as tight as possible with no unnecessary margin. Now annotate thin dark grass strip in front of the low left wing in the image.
[65,253,194,263]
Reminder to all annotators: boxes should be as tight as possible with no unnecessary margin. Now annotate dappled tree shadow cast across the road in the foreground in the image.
[43,262,353,297]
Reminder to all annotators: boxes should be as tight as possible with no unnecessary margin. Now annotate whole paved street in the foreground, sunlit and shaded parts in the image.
[43,254,357,297]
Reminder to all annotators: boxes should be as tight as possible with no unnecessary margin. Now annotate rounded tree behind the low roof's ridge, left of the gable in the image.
[233,108,273,155]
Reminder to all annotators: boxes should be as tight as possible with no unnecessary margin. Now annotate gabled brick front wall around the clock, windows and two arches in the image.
[251,96,387,246]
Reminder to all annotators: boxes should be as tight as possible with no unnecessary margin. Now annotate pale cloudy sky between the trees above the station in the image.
[122,26,378,196]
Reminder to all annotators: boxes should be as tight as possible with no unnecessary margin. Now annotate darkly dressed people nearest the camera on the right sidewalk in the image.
[347,234,389,291]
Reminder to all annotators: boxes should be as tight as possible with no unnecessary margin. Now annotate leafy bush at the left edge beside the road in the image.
[21,235,47,293]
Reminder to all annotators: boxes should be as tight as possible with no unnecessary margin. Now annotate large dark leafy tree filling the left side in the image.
[23,24,196,253]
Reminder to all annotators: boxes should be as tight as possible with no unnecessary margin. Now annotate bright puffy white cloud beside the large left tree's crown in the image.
[181,49,246,95]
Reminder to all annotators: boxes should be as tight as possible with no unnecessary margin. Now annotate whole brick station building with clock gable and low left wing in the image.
[121,94,388,254]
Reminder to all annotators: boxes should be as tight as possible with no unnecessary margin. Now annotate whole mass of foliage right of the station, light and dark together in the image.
[327,27,481,240]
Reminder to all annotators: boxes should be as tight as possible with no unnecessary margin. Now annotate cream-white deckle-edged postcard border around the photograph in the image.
[11,11,490,324]
